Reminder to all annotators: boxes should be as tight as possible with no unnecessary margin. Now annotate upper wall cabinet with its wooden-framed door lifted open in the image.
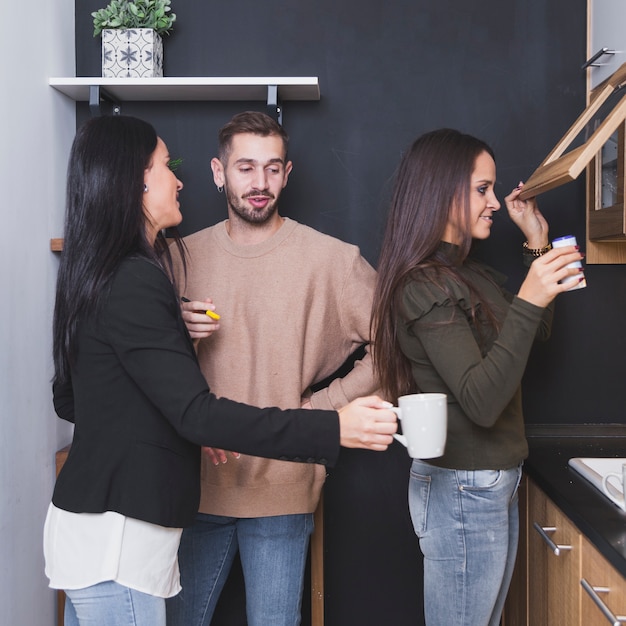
[510,0,626,264]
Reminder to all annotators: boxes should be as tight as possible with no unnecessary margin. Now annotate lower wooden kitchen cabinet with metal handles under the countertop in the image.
[502,476,626,626]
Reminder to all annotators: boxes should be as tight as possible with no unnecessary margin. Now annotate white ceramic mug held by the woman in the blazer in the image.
[392,393,448,459]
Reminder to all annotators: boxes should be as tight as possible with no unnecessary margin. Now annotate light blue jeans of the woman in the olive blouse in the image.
[409,459,521,626]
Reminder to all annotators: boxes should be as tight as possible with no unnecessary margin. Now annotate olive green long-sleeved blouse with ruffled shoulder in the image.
[398,249,552,469]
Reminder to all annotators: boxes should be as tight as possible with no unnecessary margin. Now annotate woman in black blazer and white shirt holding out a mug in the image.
[44,116,396,626]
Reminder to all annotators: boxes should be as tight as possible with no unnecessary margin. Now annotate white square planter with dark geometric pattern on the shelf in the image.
[102,28,163,78]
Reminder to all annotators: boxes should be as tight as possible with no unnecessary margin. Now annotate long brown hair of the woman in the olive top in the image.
[372,128,495,400]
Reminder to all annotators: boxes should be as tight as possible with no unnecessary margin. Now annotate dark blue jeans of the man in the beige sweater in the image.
[166,513,313,626]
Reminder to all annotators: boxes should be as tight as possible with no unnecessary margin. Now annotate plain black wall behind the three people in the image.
[76,0,626,626]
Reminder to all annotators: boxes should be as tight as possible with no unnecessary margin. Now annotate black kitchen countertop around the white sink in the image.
[524,424,626,578]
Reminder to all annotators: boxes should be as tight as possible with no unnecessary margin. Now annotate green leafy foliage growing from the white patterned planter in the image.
[91,0,176,37]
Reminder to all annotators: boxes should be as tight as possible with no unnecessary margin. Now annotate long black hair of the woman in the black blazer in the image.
[53,115,184,382]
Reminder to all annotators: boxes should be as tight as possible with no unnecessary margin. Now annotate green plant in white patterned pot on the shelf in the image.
[91,0,176,78]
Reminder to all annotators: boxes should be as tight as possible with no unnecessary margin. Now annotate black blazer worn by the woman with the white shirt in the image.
[52,257,339,527]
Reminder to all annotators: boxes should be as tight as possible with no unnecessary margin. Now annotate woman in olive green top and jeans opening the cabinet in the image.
[372,129,582,626]
